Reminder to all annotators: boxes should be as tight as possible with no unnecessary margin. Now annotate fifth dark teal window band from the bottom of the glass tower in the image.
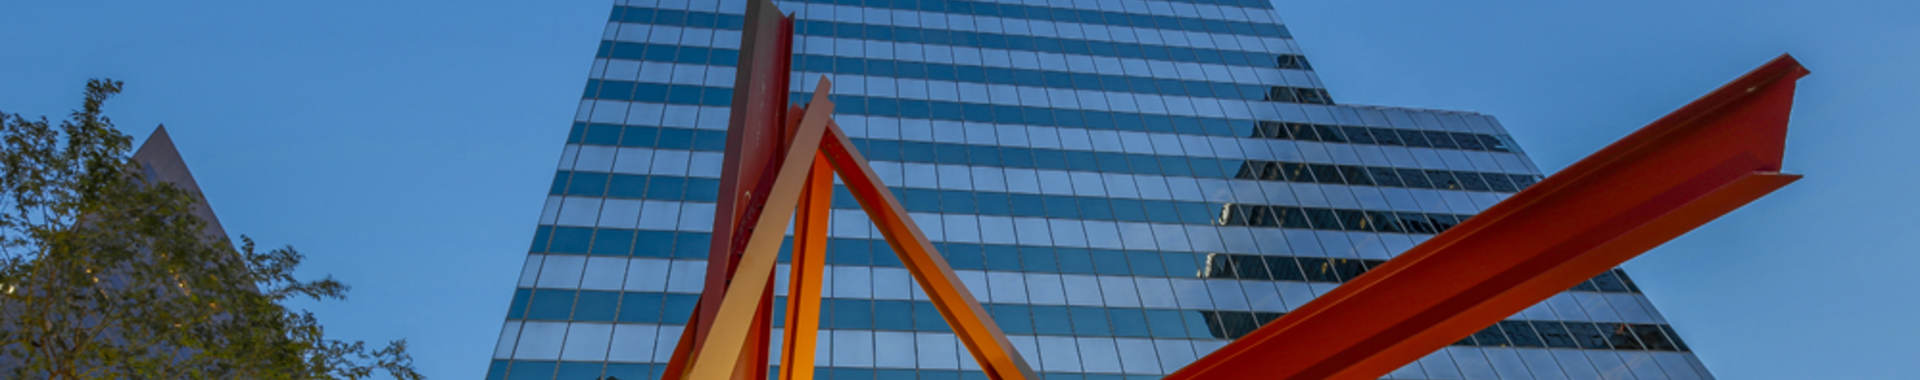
[555,125,1538,194]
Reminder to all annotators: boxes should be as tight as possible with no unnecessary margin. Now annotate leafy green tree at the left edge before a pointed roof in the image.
[0,79,420,378]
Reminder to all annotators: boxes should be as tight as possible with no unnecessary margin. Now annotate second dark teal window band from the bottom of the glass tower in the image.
[507,288,1684,351]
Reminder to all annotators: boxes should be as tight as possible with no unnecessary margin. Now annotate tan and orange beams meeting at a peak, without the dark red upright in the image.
[668,79,1033,380]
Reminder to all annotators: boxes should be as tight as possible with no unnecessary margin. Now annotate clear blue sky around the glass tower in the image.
[0,0,1920,378]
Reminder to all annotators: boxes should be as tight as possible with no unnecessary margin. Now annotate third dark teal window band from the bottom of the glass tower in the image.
[530,226,1640,294]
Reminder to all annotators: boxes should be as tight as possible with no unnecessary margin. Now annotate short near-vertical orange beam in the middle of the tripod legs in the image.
[780,154,833,380]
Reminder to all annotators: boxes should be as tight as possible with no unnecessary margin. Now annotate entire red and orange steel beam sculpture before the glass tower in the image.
[664,0,1807,380]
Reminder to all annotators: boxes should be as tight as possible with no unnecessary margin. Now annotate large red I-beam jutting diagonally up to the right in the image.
[1167,56,1807,380]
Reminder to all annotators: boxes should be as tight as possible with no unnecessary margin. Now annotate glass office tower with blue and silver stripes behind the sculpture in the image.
[488,0,1711,380]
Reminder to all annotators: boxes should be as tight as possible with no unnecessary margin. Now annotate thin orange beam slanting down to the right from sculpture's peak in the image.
[822,125,1037,380]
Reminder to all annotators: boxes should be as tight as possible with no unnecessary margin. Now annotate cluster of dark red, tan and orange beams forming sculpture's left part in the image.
[664,0,1033,380]
